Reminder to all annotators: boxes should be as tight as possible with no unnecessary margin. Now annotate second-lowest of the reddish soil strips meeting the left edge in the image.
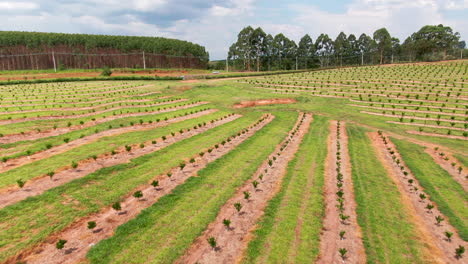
[0,109,217,175]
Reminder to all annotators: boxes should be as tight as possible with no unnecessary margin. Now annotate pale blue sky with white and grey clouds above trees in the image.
[0,0,468,60]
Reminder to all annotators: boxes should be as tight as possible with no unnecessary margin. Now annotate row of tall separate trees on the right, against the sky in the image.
[226,24,466,71]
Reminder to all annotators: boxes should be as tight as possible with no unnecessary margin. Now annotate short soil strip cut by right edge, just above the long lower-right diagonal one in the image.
[426,148,468,191]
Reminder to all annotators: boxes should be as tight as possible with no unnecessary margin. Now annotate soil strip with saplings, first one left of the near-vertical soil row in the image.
[176,114,312,264]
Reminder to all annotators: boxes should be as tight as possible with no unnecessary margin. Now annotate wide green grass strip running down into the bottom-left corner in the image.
[0,113,260,262]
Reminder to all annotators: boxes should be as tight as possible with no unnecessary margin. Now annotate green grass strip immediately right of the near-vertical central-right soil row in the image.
[347,125,434,263]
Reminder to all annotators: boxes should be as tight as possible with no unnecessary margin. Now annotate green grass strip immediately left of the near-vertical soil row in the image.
[243,116,329,263]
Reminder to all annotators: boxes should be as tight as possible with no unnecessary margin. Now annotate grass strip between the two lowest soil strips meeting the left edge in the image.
[0,111,228,188]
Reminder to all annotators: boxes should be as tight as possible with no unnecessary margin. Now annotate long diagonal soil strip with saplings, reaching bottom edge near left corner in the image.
[15,115,274,264]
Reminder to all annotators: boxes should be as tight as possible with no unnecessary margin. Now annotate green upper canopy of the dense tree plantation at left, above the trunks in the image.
[0,31,209,62]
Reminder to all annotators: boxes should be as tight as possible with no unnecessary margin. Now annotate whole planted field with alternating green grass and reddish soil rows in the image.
[0,60,468,263]
